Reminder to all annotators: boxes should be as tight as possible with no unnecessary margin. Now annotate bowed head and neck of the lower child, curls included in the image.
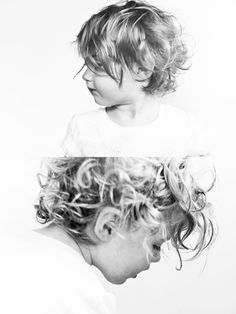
[36,157,214,313]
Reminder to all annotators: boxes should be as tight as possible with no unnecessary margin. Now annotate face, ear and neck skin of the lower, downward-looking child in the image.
[35,207,165,284]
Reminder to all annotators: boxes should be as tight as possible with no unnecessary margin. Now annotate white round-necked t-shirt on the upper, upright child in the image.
[62,104,208,157]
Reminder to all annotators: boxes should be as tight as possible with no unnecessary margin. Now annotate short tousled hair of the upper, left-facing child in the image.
[76,1,189,95]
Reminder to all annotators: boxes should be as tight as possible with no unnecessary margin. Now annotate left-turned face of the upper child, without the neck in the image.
[83,67,143,107]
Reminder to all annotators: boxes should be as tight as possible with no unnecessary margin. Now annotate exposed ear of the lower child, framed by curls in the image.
[94,206,121,242]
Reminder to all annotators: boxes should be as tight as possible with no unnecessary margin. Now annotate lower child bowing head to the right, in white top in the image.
[0,157,214,314]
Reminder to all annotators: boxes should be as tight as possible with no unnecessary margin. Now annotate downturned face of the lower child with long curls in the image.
[95,227,165,284]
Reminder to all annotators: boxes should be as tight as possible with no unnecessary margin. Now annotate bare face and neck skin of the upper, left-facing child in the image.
[83,66,159,126]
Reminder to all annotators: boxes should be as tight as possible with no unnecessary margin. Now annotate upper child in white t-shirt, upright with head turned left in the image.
[62,1,207,157]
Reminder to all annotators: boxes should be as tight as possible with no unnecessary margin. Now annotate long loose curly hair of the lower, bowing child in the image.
[35,157,215,268]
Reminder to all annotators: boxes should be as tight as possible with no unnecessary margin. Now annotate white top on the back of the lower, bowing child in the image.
[0,231,115,314]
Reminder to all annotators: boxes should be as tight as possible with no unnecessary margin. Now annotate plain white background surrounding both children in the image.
[0,0,236,314]
